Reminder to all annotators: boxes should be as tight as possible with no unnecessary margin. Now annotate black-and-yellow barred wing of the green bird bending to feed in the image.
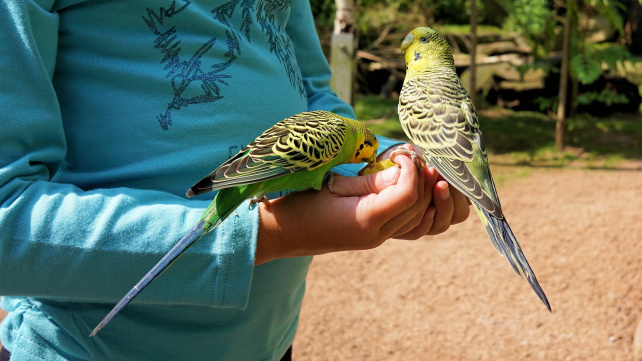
[187,111,347,197]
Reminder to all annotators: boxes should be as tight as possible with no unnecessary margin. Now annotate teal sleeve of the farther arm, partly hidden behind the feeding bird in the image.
[286,1,404,176]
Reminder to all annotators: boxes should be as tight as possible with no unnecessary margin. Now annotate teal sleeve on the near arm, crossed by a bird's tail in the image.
[0,0,258,308]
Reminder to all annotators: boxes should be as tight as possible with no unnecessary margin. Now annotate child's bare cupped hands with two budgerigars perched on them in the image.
[255,149,468,264]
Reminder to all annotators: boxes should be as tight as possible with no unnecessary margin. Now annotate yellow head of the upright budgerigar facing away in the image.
[401,27,455,71]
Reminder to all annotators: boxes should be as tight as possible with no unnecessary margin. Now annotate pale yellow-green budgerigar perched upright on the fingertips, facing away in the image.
[399,27,551,311]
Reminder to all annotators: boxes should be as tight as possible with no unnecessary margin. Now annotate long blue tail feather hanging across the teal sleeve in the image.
[89,221,207,337]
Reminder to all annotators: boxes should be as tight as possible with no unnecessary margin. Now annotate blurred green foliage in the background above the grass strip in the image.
[311,0,642,115]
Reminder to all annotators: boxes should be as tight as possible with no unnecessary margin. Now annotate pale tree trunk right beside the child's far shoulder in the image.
[330,0,355,105]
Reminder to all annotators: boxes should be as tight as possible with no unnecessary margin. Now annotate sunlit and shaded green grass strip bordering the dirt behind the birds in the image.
[355,96,642,168]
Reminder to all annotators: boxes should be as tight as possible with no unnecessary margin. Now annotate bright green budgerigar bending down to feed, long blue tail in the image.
[91,111,379,336]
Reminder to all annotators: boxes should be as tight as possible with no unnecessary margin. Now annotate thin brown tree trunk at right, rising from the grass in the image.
[555,0,573,152]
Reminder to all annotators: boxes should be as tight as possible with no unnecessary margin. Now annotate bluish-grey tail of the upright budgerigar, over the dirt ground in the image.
[473,203,551,311]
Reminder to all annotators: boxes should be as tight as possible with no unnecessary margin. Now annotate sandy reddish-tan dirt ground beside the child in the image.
[0,163,642,361]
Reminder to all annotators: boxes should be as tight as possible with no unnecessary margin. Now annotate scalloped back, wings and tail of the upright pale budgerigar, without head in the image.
[399,74,550,310]
